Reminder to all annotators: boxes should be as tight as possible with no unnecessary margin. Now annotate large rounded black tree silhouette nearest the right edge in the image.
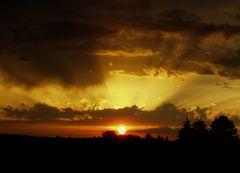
[210,115,238,143]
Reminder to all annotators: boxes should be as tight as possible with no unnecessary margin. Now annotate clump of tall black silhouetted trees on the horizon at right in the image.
[177,115,239,144]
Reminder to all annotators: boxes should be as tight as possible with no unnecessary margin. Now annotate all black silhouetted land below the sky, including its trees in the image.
[0,116,240,170]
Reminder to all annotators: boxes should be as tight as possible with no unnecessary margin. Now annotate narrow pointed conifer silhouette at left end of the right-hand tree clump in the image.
[177,118,195,143]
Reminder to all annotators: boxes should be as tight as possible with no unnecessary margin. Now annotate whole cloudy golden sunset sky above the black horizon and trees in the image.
[0,0,240,137]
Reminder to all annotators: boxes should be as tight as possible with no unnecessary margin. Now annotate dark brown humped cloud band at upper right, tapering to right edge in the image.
[155,9,240,38]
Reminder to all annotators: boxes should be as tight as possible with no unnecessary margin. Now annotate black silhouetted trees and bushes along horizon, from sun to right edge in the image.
[102,115,239,144]
